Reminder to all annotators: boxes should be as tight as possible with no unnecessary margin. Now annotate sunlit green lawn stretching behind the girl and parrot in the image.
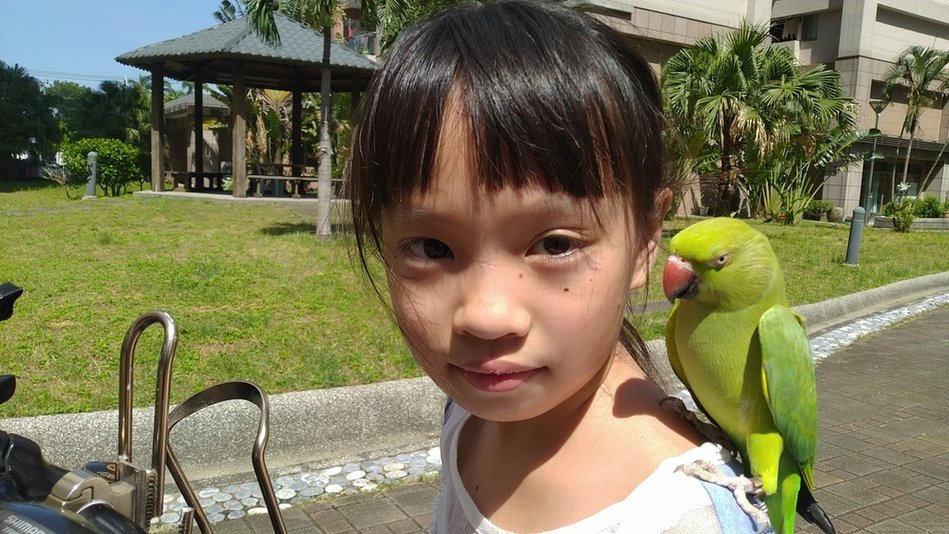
[0,181,949,416]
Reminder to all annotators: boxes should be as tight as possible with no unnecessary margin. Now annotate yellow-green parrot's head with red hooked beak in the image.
[662,217,784,309]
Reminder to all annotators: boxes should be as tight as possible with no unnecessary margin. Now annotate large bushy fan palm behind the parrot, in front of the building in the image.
[661,22,856,215]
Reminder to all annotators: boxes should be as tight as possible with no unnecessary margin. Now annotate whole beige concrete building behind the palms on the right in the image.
[584,0,949,218]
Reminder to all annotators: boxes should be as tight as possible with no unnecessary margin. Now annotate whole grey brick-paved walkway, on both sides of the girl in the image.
[215,307,949,534]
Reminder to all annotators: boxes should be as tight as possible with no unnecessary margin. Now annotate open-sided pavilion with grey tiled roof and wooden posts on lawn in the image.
[115,13,377,197]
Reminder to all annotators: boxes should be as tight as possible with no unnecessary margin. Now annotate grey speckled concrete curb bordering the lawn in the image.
[0,272,949,488]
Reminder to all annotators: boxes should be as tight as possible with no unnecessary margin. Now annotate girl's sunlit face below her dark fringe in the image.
[383,118,649,421]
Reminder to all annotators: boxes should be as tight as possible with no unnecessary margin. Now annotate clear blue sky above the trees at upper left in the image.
[0,0,231,88]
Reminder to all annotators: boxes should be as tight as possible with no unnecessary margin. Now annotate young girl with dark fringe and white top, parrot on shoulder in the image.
[351,0,752,534]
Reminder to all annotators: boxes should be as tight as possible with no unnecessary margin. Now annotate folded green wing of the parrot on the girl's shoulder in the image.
[758,305,817,487]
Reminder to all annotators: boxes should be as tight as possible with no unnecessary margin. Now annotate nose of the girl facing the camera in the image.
[452,266,531,340]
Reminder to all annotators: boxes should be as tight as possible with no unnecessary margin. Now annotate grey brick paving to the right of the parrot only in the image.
[801,307,949,534]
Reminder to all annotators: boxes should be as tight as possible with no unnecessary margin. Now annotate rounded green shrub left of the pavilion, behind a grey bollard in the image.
[62,138,143,196]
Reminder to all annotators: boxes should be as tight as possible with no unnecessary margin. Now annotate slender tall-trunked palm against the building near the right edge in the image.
[883,45,949,197]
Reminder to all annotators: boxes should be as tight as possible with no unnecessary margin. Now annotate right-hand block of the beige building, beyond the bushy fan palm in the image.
[771,0,949,218]
